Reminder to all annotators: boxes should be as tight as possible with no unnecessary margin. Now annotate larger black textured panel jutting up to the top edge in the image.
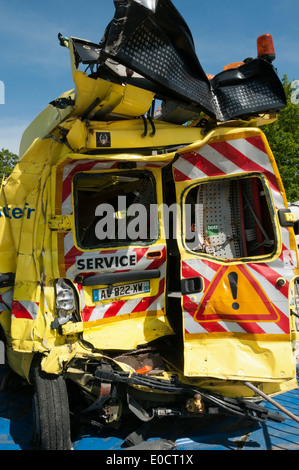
[101,0,213,113]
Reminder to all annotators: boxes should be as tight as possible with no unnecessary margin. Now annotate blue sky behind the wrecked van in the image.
[0,0,299,153]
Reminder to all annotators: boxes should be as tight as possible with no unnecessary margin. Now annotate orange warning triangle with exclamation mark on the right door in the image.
[194,265,280,323]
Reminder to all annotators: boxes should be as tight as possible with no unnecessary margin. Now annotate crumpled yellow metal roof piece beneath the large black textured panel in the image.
[19,35,155,156]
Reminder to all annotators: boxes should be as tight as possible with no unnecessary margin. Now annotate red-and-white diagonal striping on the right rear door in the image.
[178,135,293,334]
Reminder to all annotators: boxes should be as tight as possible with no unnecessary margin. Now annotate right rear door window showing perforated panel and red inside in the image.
[185,176,277,260]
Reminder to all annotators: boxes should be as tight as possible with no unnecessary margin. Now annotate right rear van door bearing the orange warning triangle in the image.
[173,130,298,382]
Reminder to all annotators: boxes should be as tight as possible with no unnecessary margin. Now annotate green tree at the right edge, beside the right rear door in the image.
[262,75,299,202]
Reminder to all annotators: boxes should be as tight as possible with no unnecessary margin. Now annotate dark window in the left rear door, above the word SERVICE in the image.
[74,171,158,249]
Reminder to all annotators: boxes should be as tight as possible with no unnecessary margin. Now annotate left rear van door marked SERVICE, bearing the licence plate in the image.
[53,157,173,349]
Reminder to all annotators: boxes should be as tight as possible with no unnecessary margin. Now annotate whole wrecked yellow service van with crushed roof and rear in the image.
[0,0,299,450]
